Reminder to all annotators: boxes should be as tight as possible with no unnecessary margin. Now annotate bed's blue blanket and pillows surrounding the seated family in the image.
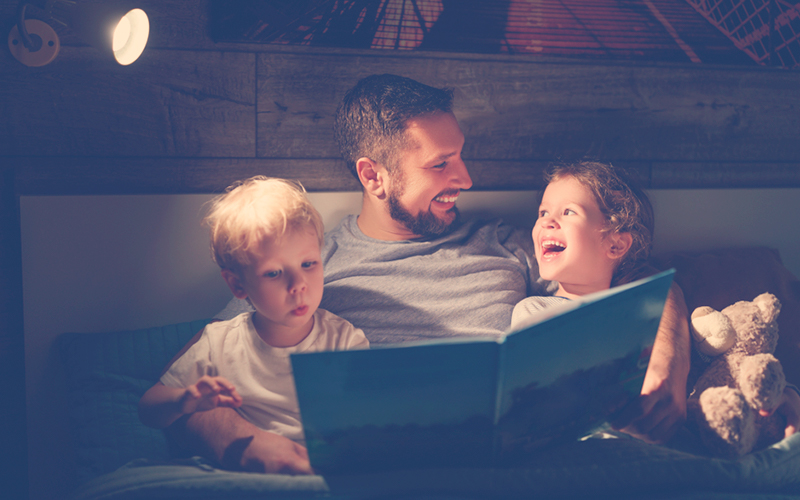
[58,247,800,500]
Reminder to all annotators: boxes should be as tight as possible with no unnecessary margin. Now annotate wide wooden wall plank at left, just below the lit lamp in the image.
[0,47,255,157]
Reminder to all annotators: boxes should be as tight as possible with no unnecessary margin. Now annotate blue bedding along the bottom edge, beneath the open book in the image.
[74,435,800,500]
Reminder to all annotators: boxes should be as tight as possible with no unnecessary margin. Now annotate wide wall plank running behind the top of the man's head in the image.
[258,53,800,162]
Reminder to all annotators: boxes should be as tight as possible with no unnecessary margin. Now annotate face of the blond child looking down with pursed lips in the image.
[223,228,323,347]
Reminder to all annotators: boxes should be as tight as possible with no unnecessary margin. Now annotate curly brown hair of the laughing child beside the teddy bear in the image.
[545,161,655,286]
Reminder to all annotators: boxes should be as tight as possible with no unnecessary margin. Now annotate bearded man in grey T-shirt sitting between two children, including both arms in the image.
[174,75,689,473]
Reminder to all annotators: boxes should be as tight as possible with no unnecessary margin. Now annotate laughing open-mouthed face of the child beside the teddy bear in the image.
[533,177,629,297]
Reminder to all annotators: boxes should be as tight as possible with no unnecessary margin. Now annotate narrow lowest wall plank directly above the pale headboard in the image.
[14,156,800,195]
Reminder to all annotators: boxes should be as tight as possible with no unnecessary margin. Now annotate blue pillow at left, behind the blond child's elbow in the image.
[58,320,209,483]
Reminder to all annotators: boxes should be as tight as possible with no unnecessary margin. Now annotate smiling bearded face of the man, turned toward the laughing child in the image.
[388,112,472,236]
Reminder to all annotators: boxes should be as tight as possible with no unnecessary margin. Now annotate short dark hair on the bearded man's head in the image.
[333,74,453,178]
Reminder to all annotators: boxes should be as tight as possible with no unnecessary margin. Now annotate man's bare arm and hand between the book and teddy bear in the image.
[613,283,691,443]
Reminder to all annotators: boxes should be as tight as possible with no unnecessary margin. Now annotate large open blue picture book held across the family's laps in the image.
[291,270,674,474]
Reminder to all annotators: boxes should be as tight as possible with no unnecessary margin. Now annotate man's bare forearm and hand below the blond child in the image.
[167,408,314,474]
